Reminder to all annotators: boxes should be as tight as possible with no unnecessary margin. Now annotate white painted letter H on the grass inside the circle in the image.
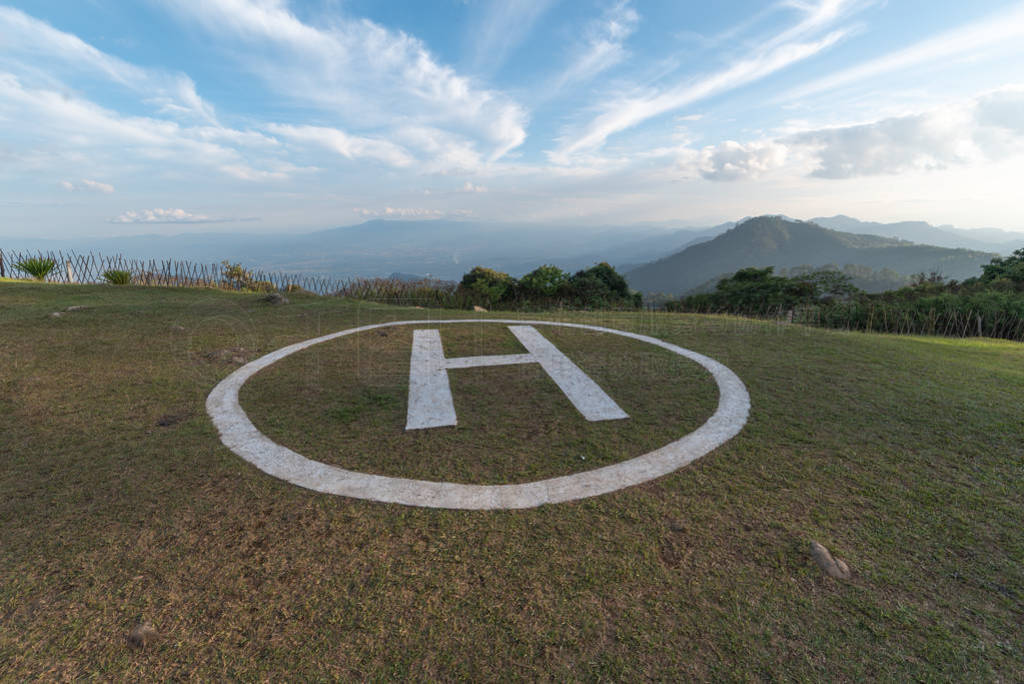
[406,326,629,430]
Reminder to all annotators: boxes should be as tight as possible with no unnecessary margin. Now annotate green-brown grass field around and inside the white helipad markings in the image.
[0,283,1024,681]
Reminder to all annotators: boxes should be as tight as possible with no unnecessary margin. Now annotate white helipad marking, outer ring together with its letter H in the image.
[206,318,750,509]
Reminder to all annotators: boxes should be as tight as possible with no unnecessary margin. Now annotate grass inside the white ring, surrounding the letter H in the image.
[241,324,718,484]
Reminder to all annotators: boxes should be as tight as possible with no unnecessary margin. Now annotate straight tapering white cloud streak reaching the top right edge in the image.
[778,4,1024,101]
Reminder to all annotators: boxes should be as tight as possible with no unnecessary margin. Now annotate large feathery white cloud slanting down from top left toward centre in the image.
[161,0,527,160]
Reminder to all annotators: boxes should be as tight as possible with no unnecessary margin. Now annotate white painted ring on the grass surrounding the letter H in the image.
[206,318,751,510]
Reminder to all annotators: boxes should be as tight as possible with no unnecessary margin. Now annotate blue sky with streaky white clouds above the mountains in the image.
[0,0,1024,238]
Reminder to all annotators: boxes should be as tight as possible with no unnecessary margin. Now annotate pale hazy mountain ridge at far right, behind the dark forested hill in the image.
[811,214,1024,255]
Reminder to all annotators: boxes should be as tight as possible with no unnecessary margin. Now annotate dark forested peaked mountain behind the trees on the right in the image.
[626,216,996,295]
